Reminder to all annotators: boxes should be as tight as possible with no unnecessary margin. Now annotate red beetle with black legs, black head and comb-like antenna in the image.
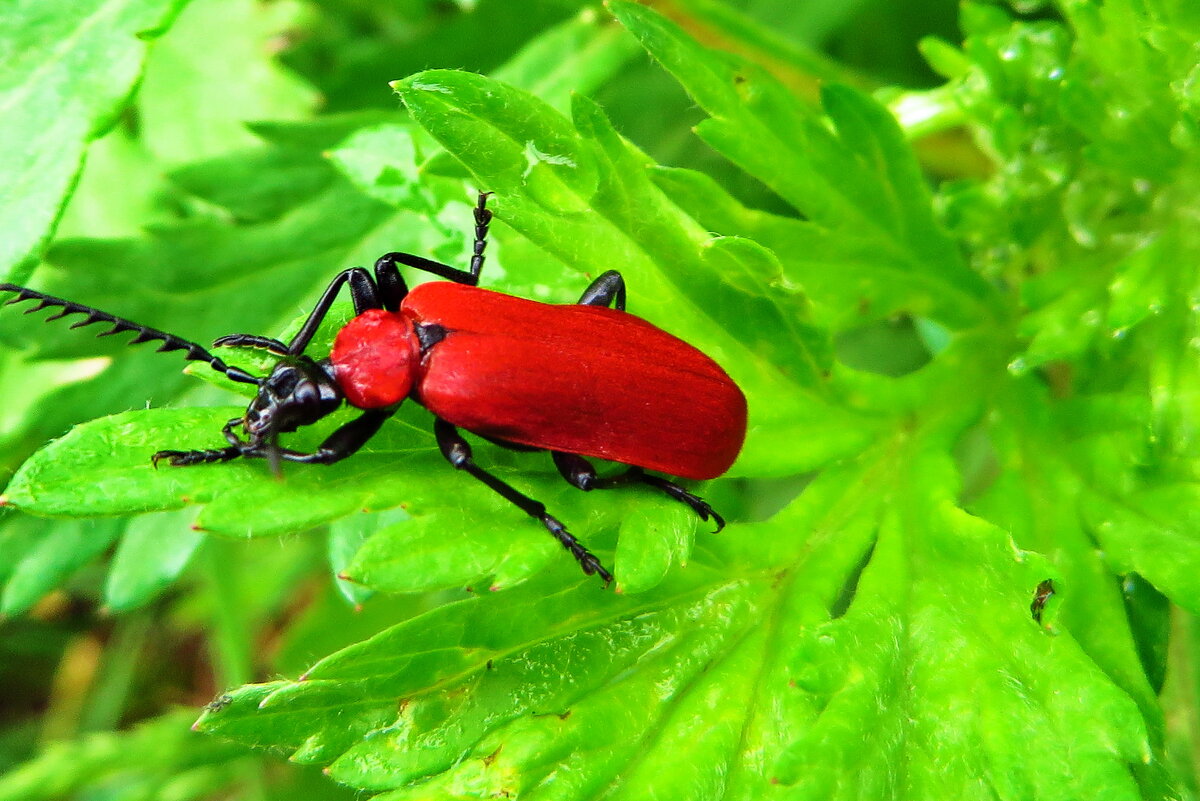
[0,193,746,582]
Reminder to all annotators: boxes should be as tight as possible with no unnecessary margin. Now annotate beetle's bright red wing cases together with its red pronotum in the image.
[330,283,746,480]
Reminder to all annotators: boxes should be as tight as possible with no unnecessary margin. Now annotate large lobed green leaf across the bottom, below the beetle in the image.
[189,447,1171,799]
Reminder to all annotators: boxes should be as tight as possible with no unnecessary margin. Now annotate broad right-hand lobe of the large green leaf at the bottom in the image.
[778,501,1152,799]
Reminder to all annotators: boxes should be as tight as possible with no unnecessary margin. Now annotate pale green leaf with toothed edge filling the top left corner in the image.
[0,0,184,278]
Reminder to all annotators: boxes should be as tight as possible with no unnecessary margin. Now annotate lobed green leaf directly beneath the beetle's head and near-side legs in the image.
[5,408,694,592]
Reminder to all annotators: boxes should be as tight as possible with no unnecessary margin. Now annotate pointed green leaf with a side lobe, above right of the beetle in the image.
[610,0,996,327]
